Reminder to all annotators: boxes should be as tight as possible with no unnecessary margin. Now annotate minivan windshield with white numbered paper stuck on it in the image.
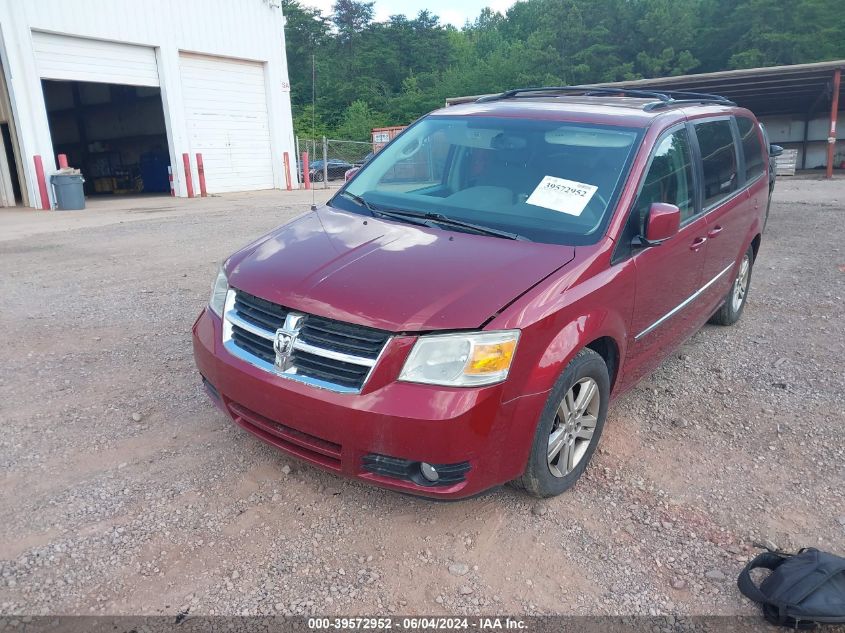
[329,115,641,245]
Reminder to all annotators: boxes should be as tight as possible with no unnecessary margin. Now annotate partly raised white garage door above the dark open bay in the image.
[32,31,158,86]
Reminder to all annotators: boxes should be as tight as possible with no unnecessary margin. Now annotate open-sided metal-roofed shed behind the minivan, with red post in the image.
[596,59,845,178]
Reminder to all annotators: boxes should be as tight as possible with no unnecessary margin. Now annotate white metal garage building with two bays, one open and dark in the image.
[0,0,296,208]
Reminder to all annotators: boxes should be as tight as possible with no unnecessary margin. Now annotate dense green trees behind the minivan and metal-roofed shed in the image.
[282,0,845,140]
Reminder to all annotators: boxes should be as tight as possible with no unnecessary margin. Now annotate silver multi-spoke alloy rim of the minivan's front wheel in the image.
[546,378,601,477]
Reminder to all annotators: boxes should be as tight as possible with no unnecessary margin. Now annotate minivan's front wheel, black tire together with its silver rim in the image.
[513,348,610,498]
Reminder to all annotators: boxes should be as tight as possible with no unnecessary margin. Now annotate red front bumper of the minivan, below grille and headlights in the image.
[193,309,546,499]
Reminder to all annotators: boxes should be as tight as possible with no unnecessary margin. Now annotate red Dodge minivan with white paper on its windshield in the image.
[193,87,769,499]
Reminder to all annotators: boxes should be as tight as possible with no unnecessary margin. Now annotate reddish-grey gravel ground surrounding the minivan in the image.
[0,180,845,615]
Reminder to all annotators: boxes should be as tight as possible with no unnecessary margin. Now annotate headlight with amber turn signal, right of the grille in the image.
[399,330,519,387]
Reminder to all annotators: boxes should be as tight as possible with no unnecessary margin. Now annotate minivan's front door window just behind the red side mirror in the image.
[635,128,695,234]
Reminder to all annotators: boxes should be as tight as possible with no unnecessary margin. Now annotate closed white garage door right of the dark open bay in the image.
[180,53,273,193]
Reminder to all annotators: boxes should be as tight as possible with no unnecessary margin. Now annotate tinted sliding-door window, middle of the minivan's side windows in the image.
[695,120,739,208]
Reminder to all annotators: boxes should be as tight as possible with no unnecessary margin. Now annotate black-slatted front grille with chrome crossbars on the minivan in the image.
[218,288,390,392]
